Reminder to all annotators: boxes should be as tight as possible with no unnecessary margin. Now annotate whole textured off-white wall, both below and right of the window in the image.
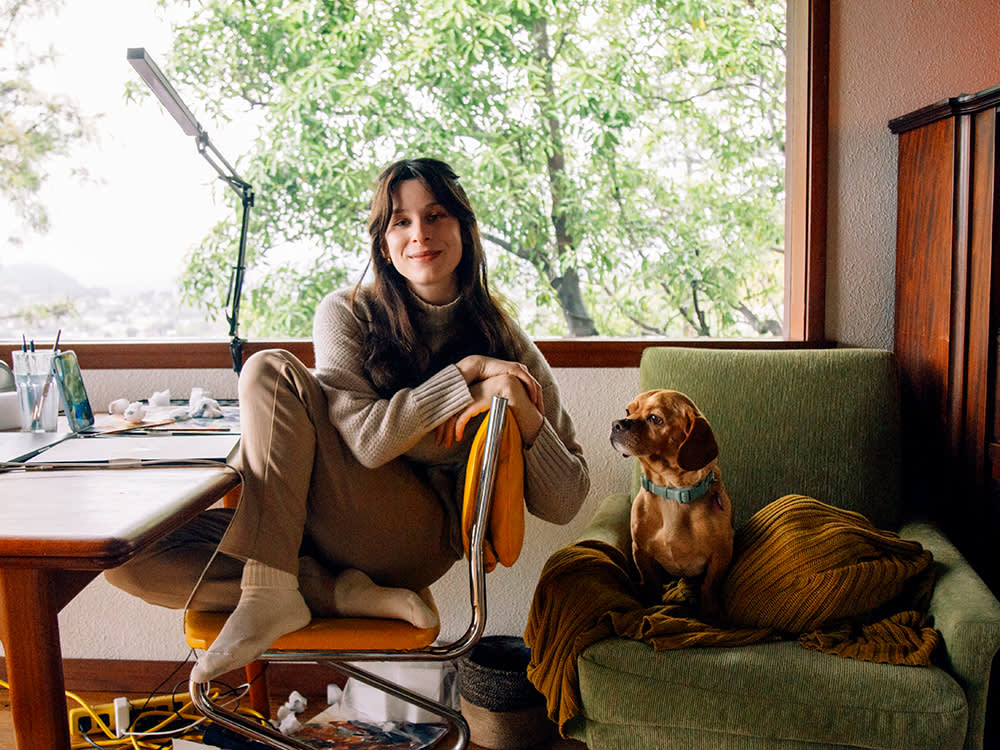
[43,0,1000,659]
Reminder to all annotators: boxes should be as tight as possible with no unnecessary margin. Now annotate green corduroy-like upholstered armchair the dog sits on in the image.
[532,347,1000,750]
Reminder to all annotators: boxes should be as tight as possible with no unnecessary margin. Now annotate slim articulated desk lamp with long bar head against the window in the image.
[127,47,253,372]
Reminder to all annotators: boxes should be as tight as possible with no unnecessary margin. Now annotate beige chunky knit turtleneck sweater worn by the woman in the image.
[313,289,590,549]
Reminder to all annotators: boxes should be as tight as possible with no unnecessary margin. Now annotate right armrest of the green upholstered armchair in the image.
[900,522,1000,750]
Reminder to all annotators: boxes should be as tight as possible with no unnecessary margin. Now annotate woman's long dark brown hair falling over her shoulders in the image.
[354,159,517,397]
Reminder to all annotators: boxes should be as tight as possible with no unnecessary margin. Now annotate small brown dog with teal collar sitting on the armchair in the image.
[611,390,733,615]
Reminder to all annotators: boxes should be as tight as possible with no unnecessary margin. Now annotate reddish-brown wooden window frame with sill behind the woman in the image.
[3,0,831,370]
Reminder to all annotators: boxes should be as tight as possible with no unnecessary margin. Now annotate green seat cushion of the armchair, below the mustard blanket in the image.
[568,638,968,750]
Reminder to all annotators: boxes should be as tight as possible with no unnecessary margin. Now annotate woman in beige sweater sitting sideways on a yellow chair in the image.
[106,159,589,681]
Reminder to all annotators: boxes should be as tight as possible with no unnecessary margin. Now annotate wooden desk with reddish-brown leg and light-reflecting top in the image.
[0,464,240,750]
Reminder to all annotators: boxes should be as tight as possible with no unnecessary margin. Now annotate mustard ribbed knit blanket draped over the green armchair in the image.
[524,495,940,731]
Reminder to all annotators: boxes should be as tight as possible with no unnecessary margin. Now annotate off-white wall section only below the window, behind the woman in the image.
[50,369,638,660]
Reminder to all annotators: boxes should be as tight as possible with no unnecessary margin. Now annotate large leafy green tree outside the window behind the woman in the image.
[161,0,785,336]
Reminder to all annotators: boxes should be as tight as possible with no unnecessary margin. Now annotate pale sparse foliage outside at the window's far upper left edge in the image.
[0,0,89,244]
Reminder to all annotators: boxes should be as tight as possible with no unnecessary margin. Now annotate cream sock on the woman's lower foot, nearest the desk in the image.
[191,560,312,682]
